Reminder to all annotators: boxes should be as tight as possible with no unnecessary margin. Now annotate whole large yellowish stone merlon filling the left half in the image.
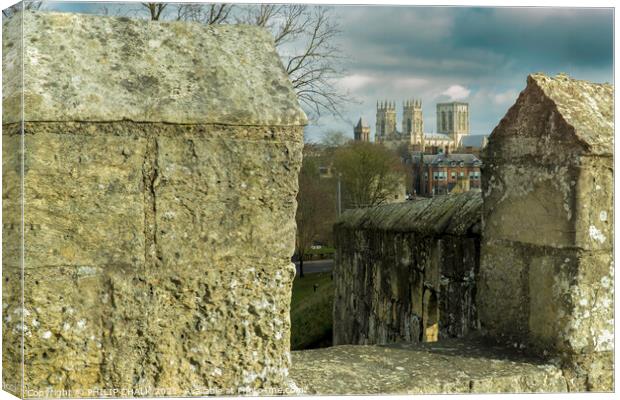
[3,13,306,397]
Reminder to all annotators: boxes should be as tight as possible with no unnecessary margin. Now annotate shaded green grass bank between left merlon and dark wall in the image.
[291,272,334,350]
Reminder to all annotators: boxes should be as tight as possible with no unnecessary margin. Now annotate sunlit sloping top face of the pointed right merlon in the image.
[525,73,614,154]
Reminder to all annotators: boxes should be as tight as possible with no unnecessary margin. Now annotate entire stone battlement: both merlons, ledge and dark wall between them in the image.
[2,8,614,397]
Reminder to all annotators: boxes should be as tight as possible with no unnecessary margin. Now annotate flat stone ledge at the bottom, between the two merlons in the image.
[290,339,567,395]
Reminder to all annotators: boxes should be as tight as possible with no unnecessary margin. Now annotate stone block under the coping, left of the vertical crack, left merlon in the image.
[24,131,145,268]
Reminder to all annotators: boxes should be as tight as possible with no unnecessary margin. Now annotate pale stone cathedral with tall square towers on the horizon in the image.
[375,100,469,153]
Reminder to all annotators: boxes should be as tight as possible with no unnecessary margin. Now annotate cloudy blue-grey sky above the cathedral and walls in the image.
[31,3,613,141]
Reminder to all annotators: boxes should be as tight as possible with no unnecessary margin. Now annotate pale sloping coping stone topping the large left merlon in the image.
[2,12,307,126]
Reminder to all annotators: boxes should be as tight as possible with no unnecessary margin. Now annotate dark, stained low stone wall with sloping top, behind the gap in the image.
[334,192,482,345]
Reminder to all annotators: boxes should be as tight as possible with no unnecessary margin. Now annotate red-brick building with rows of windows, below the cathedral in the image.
[413,153,482,197]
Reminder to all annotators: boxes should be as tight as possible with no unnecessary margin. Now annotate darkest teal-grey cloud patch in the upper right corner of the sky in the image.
[452,8,613,68]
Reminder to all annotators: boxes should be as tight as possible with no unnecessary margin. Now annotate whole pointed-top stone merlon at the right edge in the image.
[477,74,614,391]
